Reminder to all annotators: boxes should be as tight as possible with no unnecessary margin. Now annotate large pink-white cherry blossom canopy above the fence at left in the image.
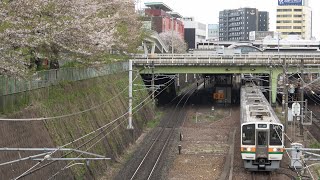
[0,0,141,75]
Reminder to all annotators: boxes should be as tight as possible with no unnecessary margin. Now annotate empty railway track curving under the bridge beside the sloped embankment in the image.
[126,88,196,180]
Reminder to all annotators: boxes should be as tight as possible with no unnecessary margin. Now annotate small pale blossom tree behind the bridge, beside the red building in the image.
[159,31,187,53]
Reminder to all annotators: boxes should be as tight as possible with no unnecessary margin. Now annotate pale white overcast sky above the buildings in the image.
[138,0,320,40]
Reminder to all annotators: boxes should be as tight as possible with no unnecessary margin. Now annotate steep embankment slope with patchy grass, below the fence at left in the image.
[0,73,154,179]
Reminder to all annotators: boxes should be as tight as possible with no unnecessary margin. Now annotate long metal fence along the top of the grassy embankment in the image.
[0,62,129,96]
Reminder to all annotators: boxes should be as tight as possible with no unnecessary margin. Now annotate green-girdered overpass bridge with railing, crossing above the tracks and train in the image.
[133,53,320,103]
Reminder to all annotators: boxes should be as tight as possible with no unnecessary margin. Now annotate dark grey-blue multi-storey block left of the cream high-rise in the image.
[219,8,269,41]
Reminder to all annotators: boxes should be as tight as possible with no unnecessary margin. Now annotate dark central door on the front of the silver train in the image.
[256,129,269,169]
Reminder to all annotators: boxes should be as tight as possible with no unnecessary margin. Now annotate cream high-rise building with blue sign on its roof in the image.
[277,0,312,39]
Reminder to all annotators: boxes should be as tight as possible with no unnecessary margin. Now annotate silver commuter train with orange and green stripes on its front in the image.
[240,83,284,171]
